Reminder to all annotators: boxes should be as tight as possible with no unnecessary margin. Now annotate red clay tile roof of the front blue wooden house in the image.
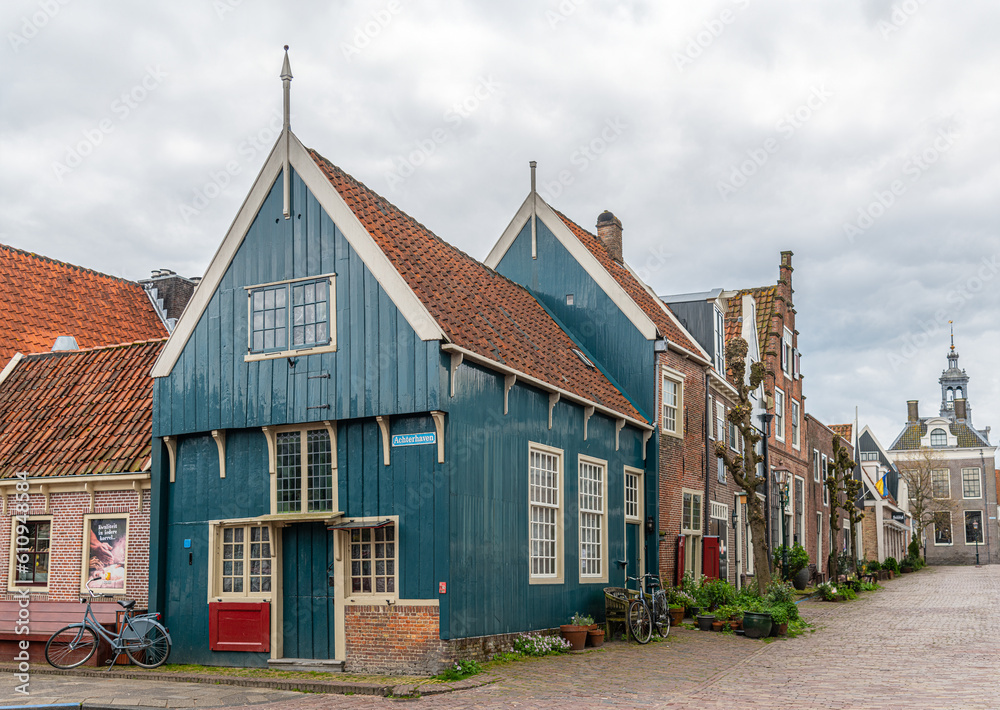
[310,150,645,421]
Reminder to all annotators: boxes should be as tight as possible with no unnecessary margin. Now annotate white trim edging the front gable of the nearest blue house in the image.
[151,131,444,377]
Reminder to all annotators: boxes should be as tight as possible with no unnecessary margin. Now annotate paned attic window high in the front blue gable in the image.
[250,279,330,353]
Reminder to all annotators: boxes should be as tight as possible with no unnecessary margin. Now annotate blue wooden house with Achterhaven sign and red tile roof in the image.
[150,52,656,672]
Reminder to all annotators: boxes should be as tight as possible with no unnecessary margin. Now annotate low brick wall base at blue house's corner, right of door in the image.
[344,606,450,674]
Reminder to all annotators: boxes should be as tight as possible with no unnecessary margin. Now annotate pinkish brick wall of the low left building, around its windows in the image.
[0,492,149,608]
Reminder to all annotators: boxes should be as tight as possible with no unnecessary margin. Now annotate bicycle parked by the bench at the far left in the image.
[45,588,171,670]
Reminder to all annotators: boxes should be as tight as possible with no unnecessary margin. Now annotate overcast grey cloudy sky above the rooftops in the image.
[0,0,1000,446]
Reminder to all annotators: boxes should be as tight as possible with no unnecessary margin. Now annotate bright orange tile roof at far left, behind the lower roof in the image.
[0,244,167,363]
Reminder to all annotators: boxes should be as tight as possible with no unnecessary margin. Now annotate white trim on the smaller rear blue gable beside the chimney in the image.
[485,194,659,340]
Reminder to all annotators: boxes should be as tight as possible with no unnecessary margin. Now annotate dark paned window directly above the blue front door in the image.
[275,429,333,513]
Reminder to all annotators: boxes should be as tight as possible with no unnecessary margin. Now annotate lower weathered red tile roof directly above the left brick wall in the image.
[0,339,166,478]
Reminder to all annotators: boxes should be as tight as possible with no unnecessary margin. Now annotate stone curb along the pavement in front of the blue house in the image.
[0,664,499,710]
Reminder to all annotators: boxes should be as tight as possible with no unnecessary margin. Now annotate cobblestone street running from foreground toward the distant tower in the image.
[0,566,1000,710]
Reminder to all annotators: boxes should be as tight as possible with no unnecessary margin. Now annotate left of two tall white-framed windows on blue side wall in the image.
[528,449,562,578]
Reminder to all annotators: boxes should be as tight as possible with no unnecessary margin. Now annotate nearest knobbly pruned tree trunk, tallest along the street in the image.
[715,337,771,594]
